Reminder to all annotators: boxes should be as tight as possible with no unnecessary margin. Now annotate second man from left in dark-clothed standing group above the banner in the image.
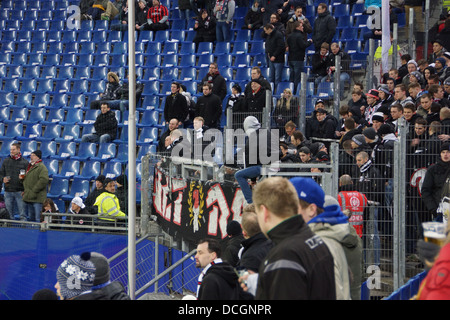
[195,83,222,128]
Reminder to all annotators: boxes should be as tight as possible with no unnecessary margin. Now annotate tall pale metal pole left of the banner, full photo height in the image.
[128,0,136,300]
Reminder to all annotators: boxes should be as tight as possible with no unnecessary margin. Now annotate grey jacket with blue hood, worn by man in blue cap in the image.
[308,205,351,300]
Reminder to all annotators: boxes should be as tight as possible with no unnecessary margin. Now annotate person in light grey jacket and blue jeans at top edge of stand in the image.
[213,0,236,42]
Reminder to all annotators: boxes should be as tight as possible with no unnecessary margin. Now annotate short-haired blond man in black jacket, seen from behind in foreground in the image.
[253,177,336,300]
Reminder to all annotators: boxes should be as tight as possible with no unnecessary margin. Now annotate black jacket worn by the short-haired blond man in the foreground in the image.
[256,215,336,300]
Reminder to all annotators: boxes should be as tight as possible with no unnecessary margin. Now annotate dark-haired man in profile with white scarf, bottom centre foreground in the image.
[195,239,241,300]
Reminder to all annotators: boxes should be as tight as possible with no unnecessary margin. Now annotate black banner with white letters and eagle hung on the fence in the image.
[153,169,246,242]
